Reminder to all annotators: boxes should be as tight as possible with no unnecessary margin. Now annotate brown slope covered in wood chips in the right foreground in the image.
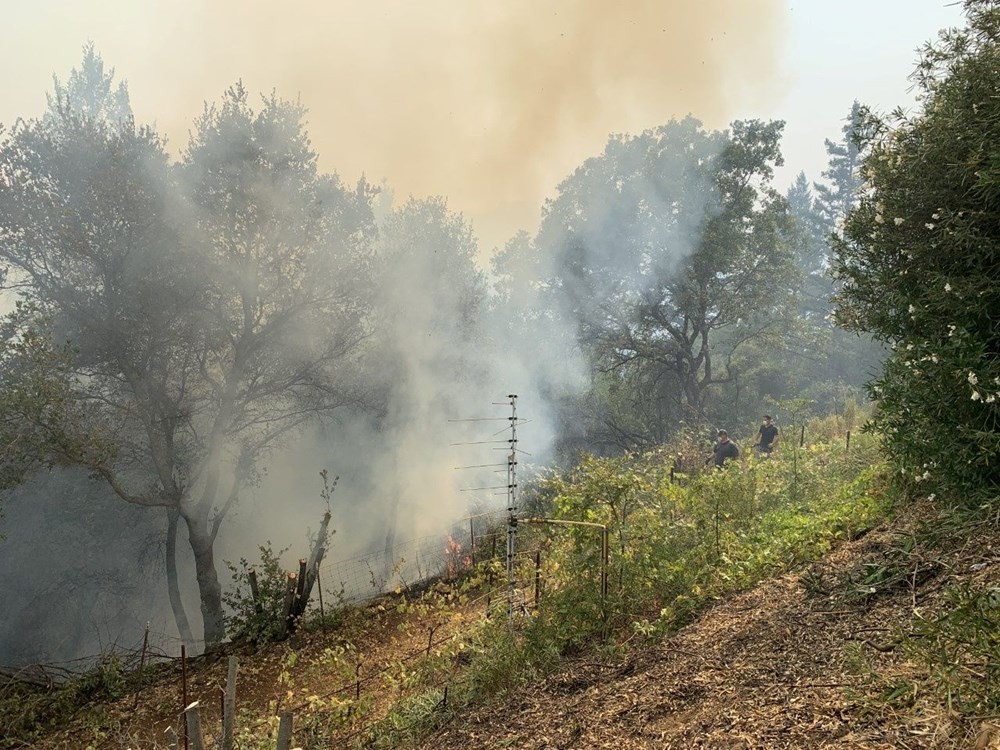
[414,526,1000,750]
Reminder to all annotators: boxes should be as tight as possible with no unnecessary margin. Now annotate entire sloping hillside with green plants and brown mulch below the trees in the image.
[0,421,1000,749]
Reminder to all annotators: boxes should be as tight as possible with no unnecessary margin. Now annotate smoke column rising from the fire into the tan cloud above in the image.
[0,0,796,664]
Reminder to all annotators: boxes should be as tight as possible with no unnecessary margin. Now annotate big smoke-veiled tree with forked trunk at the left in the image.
[0,64,373,643]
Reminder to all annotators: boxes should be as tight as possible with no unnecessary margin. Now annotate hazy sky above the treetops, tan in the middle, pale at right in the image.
[0,0,961,253]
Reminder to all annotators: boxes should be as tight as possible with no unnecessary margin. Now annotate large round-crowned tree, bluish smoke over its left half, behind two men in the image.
[536,117,794,445]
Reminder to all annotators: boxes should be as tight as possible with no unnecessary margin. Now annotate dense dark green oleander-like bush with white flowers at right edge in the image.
[836,0,1000,504]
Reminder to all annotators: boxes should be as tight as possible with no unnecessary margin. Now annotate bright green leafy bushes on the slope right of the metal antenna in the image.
[450,428,887,712]
